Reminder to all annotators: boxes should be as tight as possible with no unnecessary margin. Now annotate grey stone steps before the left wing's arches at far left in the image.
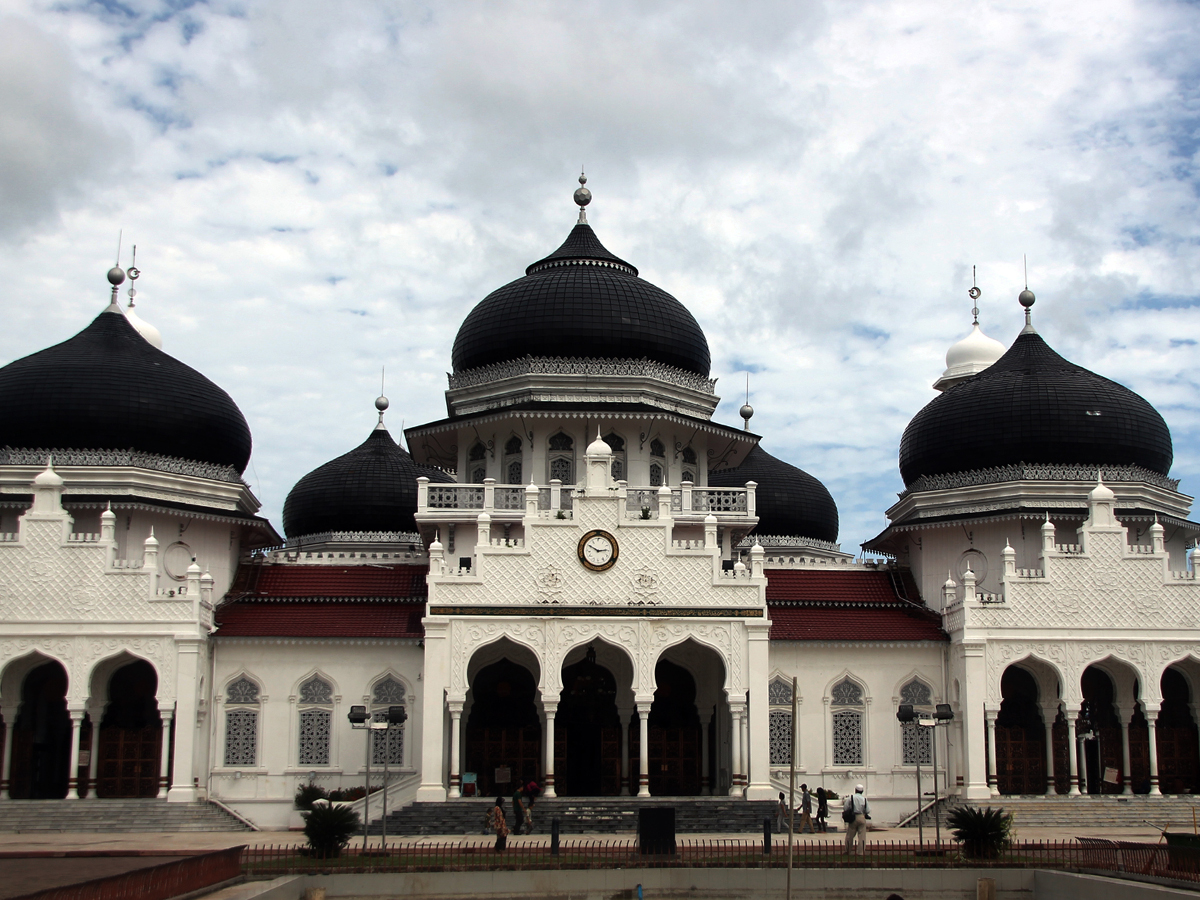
[0,799,250,834]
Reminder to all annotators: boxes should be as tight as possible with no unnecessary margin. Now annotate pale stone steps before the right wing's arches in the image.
[907,794,1200,832]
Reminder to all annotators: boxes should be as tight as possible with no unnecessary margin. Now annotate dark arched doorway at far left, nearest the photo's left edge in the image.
[8,661,71,800]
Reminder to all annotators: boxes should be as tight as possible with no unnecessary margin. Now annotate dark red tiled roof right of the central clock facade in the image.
[766,569,948,641]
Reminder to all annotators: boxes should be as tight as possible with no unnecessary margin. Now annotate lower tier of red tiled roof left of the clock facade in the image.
[216,600,425,637]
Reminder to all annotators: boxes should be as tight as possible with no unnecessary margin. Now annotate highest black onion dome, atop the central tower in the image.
[452,229,709,377]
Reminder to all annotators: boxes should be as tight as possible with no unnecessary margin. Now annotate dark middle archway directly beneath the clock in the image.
[554,647,620,797]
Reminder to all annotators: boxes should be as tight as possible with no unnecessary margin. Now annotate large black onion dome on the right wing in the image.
[900,331,1174,485]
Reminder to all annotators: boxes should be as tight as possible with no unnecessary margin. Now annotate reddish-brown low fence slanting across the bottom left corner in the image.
[12,847,244,900]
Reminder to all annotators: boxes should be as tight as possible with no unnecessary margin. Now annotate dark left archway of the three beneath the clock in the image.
[466,655,541,797]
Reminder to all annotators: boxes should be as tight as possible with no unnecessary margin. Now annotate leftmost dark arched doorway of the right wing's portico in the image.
[996,666,1046,794]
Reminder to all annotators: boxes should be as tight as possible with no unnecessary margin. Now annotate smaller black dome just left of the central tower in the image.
[283,428,454,538]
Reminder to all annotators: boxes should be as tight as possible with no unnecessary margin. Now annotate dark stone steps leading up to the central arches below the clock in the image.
[371,797,775,835]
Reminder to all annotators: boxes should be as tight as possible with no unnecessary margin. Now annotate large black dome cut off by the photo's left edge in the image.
[0,310,251,473]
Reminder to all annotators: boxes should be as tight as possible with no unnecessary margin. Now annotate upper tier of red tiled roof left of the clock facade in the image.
[229,563,428,600]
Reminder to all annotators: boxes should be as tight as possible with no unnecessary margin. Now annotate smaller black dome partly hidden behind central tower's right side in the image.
[708,445,838,542]
